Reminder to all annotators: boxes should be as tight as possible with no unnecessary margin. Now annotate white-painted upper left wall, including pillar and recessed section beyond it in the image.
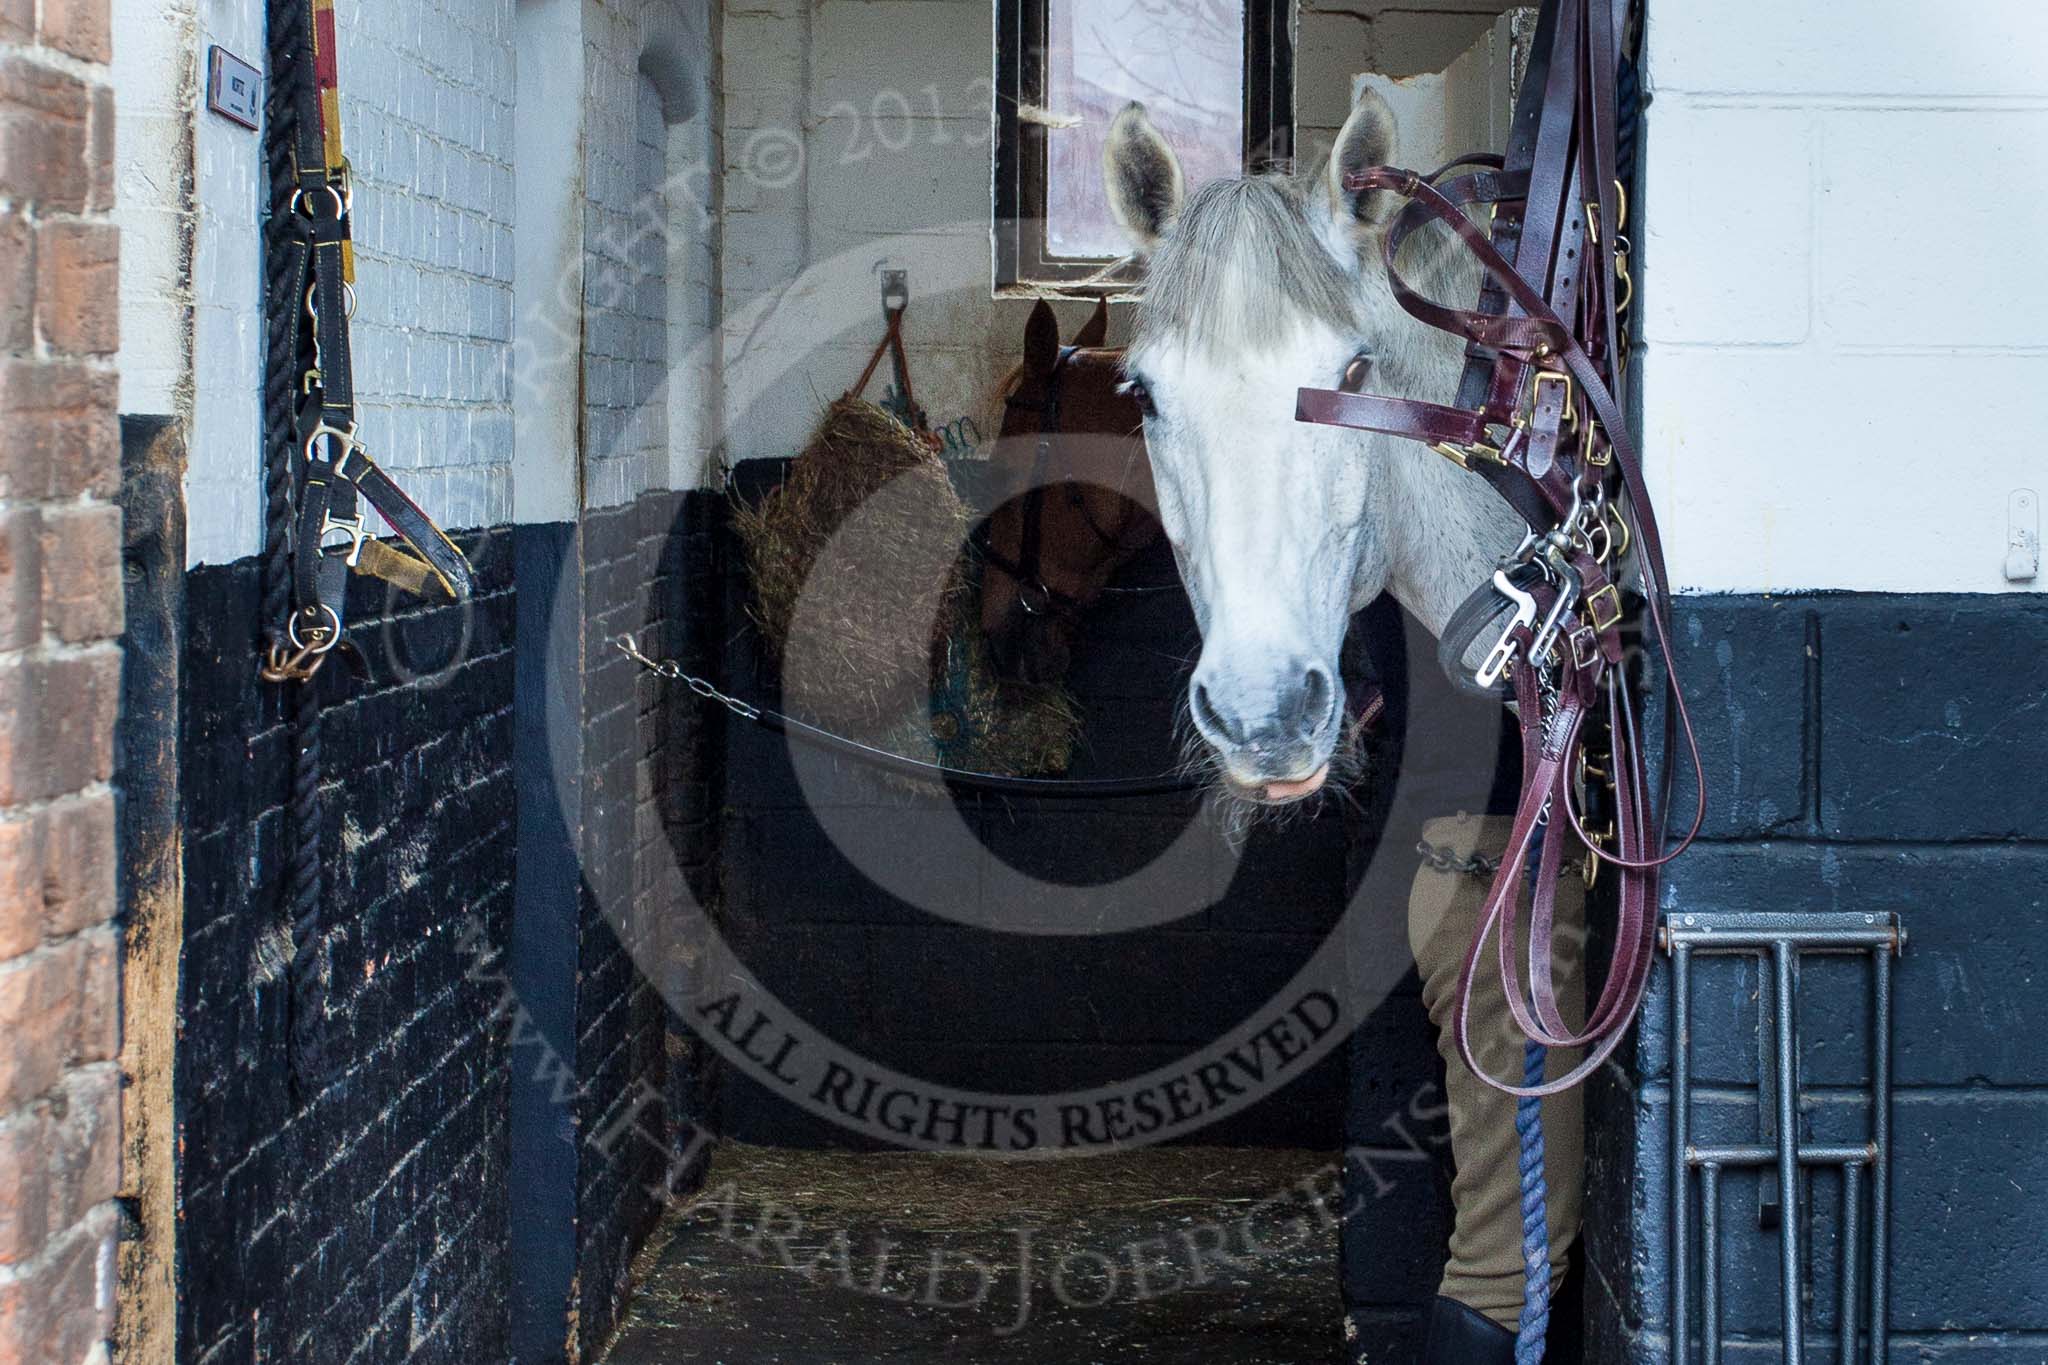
[115,0,719,565]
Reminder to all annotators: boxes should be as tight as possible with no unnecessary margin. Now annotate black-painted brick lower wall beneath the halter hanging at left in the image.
[176,534,514,1365]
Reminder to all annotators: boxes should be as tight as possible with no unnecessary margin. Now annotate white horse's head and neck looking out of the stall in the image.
[1104,94,1522,804]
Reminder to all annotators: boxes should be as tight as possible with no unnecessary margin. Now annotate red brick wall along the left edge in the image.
[0,0,121,1365]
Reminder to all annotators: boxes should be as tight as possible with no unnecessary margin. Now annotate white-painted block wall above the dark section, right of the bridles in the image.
[1640,0,2048,591]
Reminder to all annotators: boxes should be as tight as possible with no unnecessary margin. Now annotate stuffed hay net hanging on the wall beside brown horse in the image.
[733,397,1079,776]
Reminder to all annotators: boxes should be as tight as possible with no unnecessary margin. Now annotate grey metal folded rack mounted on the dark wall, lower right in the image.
[1663,911,1905,1365]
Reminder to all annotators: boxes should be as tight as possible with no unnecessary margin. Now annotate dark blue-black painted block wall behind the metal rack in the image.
[1591,596,2048,1365]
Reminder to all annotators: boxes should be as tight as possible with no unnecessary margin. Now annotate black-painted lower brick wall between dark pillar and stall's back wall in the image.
[575,493,717,1347]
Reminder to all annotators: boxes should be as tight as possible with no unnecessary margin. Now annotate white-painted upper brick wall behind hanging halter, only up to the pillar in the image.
[115,0,514,565]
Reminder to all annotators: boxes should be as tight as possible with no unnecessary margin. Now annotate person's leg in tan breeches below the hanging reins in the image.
[1409,817,1585,1330]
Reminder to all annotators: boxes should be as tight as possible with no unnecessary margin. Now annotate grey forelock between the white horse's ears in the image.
[1139,176,1364,356]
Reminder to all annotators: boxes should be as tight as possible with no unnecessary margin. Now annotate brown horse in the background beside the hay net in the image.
[977,301,1161,684]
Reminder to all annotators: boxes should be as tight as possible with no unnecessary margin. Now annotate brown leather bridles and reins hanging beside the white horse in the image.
[1296,0,1706,1097]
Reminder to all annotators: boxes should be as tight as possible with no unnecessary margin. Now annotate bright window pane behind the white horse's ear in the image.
[1047,0,1245,258]
